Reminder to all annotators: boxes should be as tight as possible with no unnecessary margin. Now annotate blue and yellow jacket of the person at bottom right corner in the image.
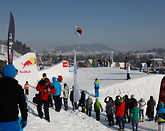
[155,103,165,123]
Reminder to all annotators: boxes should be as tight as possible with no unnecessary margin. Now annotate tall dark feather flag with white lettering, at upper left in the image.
[7,12,15,64]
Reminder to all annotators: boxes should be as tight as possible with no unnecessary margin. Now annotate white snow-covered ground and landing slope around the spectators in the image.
[22,67,163,131]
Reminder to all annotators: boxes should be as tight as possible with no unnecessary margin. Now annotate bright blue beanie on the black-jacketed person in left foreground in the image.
[2,64,18,78]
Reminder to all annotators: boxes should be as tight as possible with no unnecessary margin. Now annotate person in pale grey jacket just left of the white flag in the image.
[63,83,69,111]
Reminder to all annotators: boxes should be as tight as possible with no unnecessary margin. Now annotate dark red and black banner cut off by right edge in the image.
[158,76,165,104]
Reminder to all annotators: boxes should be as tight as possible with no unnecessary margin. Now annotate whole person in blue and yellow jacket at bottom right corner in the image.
[155,102,165,131]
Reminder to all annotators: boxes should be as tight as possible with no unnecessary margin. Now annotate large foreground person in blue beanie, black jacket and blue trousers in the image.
[0,64,27,131]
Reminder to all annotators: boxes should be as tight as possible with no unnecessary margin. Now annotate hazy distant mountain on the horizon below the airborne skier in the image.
[40,43,117,55]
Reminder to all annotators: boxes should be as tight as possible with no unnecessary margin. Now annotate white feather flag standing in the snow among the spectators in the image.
[73,51,81,102]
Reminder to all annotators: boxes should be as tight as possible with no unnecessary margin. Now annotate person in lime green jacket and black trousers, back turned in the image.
[94,98,103,121]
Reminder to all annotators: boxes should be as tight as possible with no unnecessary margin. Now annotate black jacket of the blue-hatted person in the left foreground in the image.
[0,77,27,122]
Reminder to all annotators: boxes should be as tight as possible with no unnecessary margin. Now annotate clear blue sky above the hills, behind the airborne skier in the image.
[0,0,165,50]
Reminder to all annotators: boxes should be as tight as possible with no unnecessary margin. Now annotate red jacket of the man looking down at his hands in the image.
[36,81,56,100]
